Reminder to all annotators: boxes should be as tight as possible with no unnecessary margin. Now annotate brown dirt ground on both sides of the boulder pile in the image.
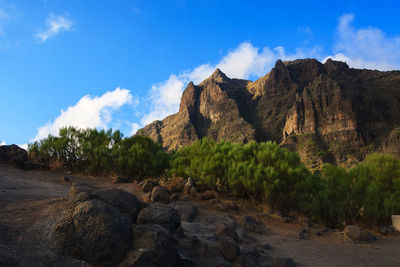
[0,164,400,266]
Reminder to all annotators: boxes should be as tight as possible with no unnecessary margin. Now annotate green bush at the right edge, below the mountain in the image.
[308,154,400,226]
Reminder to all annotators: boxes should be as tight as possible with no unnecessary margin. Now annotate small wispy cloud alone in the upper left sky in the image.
[35,14,73,43]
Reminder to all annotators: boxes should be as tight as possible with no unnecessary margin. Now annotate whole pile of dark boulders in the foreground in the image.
[41,184,291,267]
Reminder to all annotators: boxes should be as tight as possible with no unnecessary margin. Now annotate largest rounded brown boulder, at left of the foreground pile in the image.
[53,199,131,266]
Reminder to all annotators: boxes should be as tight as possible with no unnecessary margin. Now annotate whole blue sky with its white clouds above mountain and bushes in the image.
[0,0,400,148]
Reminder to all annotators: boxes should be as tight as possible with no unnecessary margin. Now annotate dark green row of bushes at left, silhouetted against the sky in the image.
[28,127,168,178]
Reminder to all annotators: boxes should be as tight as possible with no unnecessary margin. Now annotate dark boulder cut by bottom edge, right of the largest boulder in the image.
[120,224,177,267]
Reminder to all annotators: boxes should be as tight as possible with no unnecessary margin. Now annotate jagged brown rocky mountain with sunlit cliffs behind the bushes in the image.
[141,59,400,169]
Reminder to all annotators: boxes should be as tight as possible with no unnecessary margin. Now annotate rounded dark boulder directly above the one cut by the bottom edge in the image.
[137,203,181,233]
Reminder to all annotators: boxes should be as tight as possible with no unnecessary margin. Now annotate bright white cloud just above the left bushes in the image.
[30,88,132,141]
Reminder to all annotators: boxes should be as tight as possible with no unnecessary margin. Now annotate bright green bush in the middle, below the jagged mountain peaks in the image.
[169,139,312,210]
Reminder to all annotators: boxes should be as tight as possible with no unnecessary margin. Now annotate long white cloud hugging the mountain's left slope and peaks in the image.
[140,42,310,126]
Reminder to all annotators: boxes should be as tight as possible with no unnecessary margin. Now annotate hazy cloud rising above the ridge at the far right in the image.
[324,14,400,70]
